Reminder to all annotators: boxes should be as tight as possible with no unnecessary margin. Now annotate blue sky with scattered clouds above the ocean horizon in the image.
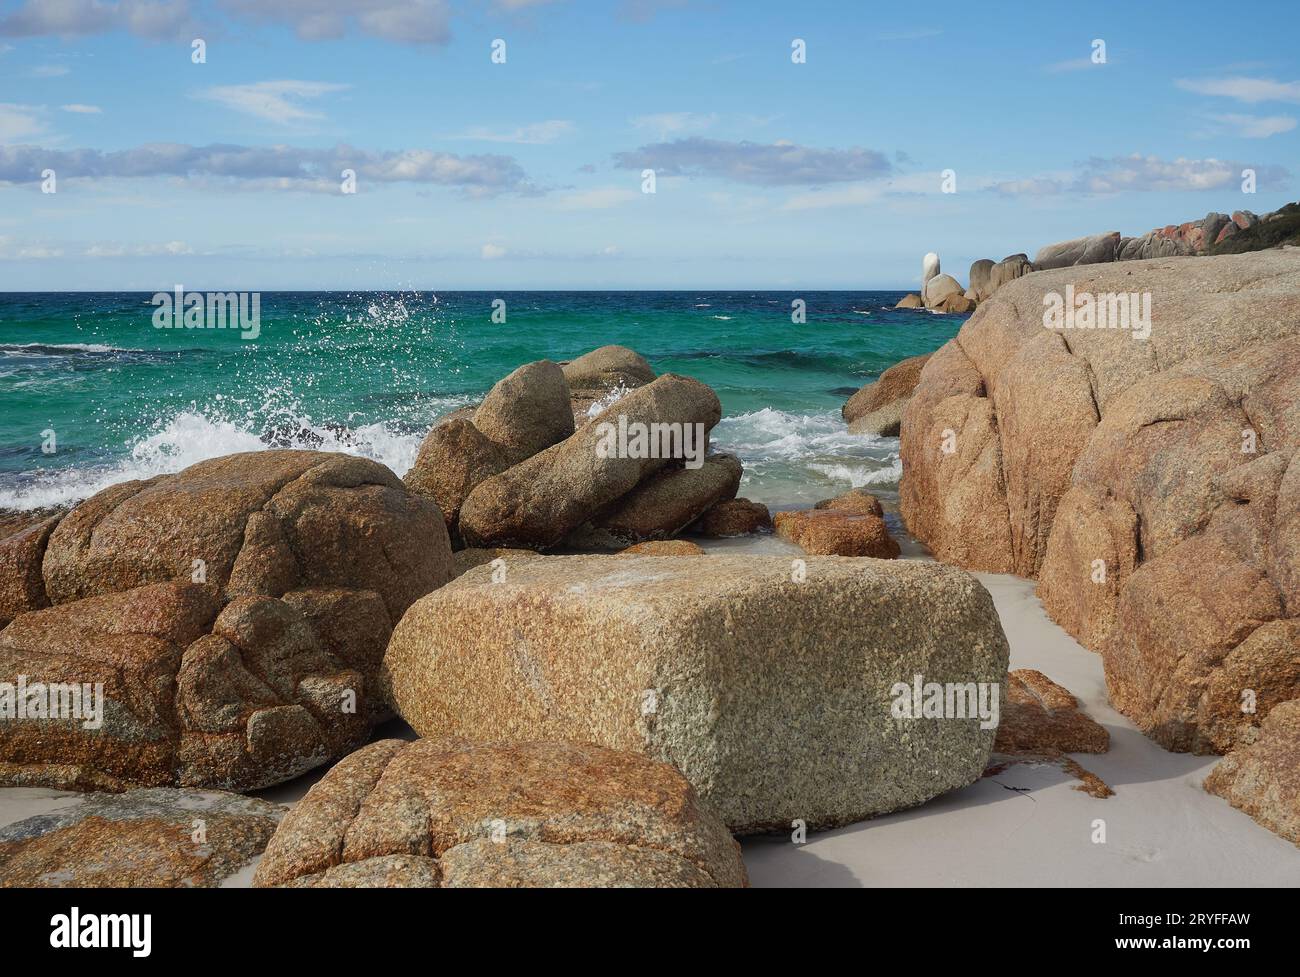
[0,0,1300,292]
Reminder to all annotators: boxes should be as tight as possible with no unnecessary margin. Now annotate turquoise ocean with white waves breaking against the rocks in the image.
[0,291,963,509]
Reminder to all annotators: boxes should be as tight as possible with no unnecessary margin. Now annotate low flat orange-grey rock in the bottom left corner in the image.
[0,787,285,889]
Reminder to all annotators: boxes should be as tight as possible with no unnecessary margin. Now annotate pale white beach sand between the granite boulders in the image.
[0,527,1300,886]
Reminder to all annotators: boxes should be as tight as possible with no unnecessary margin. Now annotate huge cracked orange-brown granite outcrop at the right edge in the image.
[900,249,1300,752]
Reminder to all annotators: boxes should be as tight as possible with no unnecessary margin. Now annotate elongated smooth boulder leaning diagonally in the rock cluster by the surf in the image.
[459,361,735,550]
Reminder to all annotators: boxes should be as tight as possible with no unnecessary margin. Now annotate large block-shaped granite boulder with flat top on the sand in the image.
[379,555,1008,831]
